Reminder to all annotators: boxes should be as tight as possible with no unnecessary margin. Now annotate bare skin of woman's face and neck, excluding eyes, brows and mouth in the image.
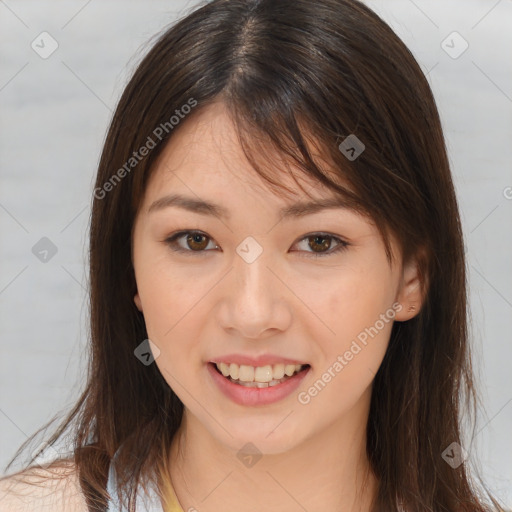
[132,103,421,512]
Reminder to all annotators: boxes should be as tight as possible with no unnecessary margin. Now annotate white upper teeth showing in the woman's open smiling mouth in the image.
[208,363,310,388]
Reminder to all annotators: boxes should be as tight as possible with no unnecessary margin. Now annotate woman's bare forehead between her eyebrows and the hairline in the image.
[142,102,351,206]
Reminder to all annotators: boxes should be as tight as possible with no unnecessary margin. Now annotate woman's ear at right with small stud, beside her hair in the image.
[395,251,428,322]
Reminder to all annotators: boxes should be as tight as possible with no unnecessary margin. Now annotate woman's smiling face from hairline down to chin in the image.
[133,104,419,453]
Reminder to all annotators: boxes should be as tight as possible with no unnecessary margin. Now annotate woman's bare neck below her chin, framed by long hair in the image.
[166,400,377,512]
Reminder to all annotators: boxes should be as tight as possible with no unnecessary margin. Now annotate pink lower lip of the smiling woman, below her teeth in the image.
[206,363,311,405]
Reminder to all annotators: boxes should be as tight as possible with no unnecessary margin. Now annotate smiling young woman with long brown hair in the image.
[3,0,499,512]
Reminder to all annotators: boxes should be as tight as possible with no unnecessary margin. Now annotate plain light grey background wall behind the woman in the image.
[0,0,512,506]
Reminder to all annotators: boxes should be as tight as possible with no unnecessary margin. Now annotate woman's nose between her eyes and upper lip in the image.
[218,247,292,340]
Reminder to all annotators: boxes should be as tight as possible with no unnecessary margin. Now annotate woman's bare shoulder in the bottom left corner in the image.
[0,461,88,512]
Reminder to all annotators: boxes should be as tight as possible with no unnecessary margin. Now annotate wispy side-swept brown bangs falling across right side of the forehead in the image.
[214,93,393,264]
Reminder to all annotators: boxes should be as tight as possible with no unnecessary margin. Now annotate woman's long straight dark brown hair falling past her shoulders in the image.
[2,0,506,512]
